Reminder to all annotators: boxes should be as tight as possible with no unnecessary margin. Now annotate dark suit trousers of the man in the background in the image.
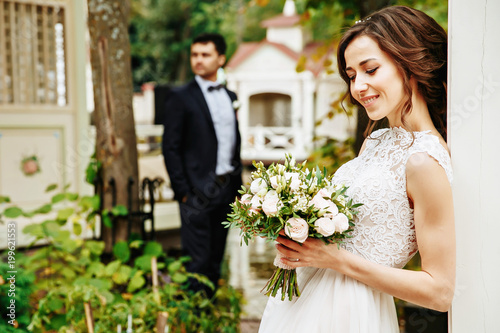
[179,175,236,296]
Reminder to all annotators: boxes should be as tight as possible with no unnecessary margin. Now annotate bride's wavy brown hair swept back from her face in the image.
[337,6,448,140]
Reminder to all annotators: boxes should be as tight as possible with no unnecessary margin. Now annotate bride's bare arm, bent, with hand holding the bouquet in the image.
[278,154,455,311]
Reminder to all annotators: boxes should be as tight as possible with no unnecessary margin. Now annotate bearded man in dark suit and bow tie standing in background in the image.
[163,34,242,296]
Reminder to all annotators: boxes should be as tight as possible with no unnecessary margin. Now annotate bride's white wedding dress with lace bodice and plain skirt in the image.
[259,127,452,333]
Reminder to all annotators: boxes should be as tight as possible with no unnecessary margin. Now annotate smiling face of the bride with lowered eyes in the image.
[345,36,406,126]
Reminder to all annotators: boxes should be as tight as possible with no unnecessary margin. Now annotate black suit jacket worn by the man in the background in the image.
[162,80,242,200]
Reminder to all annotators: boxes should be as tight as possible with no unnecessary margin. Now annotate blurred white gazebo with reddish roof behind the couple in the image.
[226,0,355,162]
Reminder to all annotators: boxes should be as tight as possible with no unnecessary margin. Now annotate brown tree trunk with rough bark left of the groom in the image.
[88,0,139,253]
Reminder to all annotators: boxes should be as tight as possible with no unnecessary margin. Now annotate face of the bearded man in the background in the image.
[191,42,226,81]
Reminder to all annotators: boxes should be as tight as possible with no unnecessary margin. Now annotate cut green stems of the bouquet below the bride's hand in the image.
[261,267,300,301]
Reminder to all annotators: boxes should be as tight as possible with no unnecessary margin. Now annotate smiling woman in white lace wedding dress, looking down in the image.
[260,6,455,333]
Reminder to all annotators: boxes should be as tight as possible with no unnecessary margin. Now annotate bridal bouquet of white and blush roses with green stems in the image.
[223,155,361,300]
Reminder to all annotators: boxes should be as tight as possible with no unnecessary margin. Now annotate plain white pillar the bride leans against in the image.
[448,0,500,333]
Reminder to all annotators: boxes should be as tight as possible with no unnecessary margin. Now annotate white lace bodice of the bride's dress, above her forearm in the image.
[333,127,453,268]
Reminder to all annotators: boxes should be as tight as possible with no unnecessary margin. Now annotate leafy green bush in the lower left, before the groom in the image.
[0,186,242,333]
